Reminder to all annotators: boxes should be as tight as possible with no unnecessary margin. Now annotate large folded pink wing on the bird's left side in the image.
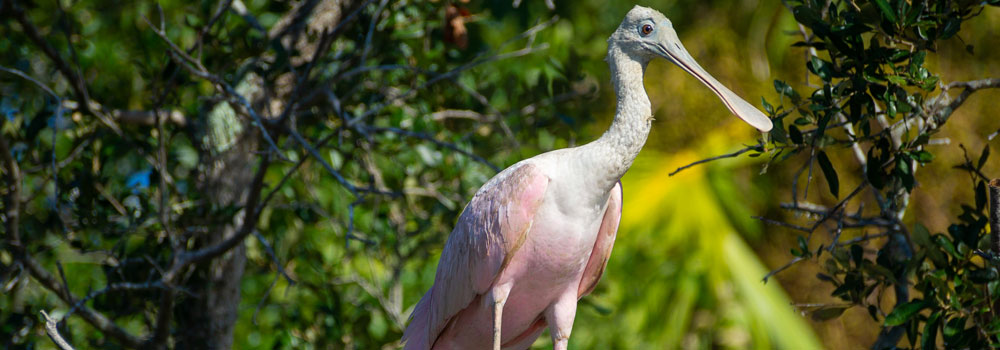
[403,164,549,349]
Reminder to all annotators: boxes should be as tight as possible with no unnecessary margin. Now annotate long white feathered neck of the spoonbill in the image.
[583,43,653,191]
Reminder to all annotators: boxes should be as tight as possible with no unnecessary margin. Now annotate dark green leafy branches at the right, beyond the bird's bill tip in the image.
[763,0,1000,348]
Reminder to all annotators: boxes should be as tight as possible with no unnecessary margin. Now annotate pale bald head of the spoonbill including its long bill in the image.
[608,6,771,132]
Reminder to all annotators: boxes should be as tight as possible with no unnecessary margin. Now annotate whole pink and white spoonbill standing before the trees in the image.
[403,6,771,350]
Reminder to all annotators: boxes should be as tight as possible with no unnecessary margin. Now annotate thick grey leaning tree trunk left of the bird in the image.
[174,0,359,350]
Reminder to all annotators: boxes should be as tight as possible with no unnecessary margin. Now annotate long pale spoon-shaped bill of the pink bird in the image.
[659,30,772,132]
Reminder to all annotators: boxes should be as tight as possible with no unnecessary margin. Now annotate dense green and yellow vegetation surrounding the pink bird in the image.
[0,0,1000,349]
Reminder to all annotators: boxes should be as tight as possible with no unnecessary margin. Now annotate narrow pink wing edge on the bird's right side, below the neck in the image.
[578,182,622,298]
